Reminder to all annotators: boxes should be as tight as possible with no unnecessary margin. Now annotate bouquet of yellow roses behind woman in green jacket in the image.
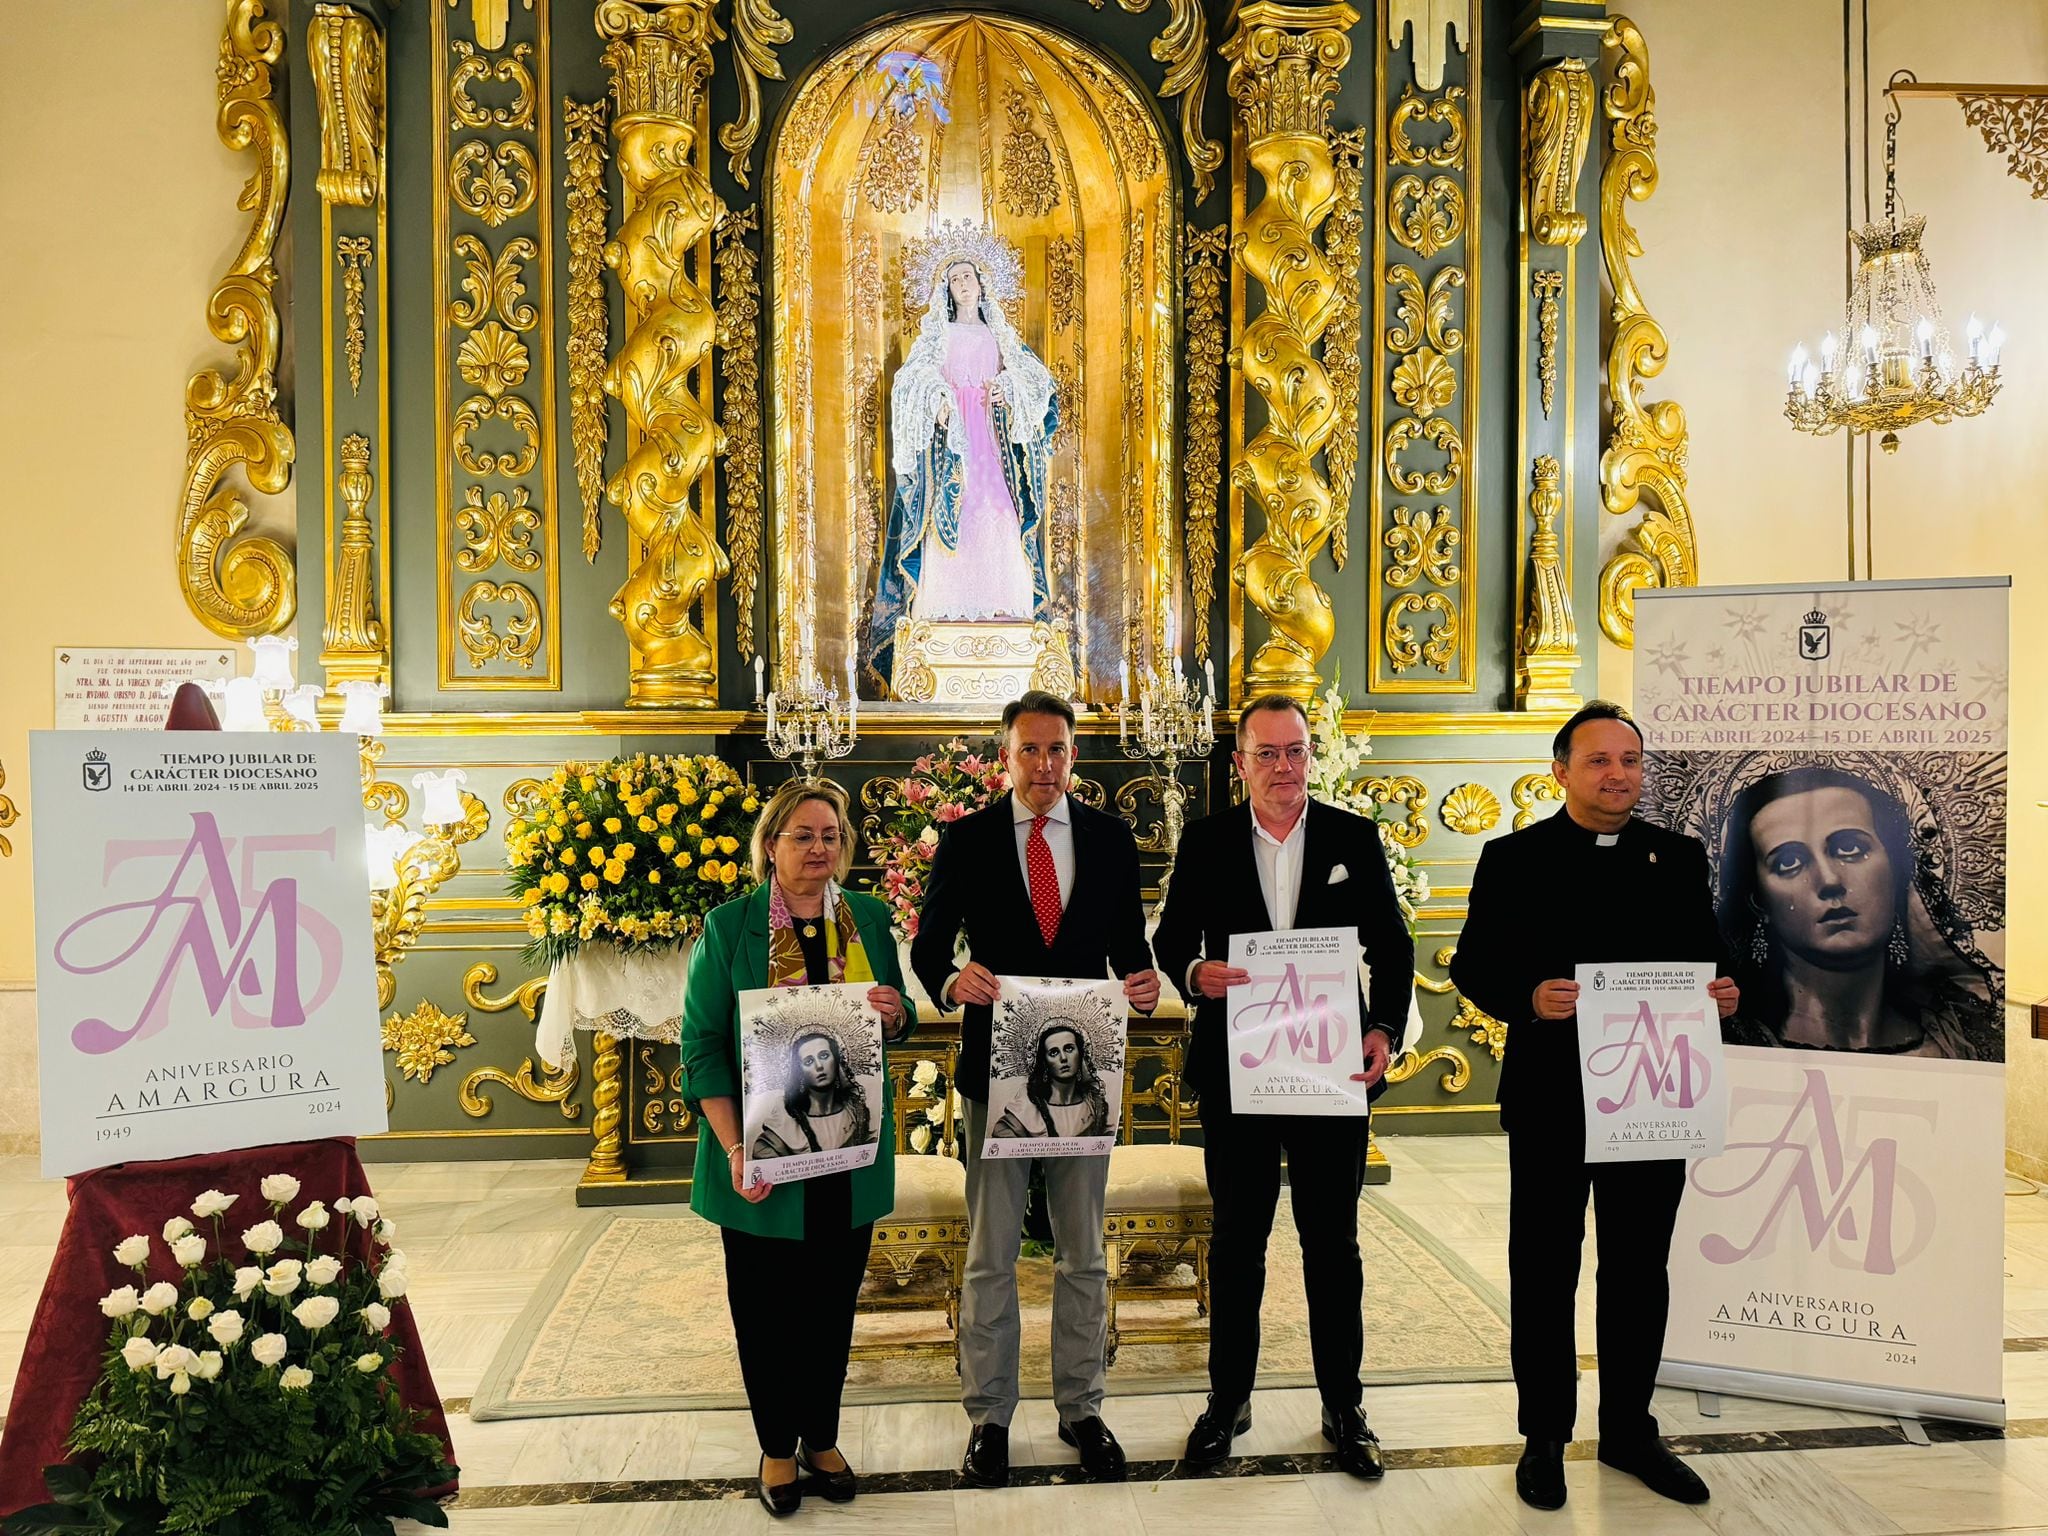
[506,754,760,967]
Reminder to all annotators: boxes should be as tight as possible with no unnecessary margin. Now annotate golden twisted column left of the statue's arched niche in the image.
[596,0,731,709]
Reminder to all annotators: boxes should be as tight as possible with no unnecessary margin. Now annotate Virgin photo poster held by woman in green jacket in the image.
[739,981,887,1184]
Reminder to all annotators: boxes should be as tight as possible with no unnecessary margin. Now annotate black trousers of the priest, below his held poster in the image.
[1507,1124,1686,1442]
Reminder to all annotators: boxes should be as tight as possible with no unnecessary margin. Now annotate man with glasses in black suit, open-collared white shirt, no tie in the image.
[1153,694,1415,1479]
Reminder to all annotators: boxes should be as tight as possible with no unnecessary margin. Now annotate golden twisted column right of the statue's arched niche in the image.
[1223,0,1358,700]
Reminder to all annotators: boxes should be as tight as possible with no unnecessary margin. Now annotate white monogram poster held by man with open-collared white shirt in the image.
[1225,928,1370,1114]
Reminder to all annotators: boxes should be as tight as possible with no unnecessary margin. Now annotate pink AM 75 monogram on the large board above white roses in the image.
[55,811,342,1055]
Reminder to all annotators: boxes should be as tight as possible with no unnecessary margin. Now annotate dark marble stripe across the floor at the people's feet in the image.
[453,1419,2048,1509]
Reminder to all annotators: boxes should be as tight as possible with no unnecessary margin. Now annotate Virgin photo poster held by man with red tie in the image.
[981,977,1128,1157]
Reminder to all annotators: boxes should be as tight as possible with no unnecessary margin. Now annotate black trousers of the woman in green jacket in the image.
[723,1174,874,1460]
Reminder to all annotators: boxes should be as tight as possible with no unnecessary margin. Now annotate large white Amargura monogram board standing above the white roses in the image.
[29,729,387,1178]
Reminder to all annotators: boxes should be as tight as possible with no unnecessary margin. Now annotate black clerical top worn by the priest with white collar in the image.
[1450,811,1726,1145]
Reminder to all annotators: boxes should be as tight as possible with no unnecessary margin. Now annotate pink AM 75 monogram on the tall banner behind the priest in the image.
[1692,1067,1937,1274]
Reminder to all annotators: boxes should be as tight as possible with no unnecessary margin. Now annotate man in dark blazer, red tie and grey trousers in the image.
[909,690,1159,1487]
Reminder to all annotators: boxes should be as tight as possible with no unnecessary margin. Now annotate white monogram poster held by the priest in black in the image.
[1575,965,1729,1163]
